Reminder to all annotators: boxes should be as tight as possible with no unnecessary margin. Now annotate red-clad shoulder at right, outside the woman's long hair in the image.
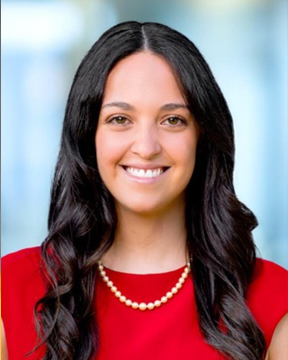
[247,258,288,346]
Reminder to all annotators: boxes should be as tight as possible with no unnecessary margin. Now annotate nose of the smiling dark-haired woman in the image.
[131,126,161,159]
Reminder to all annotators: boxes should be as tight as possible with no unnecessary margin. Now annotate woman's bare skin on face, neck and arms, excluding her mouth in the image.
[1,52,288,360]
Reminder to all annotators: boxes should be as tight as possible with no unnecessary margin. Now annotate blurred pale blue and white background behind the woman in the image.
[1,0,288,268]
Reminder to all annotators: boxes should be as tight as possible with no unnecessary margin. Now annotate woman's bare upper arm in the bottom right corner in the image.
[265,313,288,360]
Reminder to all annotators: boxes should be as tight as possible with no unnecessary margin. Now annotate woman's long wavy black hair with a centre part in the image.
[35,21,265,360]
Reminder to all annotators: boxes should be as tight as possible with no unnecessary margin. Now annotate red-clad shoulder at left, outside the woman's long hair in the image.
[1,247,46,359]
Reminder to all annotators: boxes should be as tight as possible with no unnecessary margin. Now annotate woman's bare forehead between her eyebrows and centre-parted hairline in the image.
[103,52,184,105]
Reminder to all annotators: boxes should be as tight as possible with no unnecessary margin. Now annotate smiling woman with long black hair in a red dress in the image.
[2,22,288,360]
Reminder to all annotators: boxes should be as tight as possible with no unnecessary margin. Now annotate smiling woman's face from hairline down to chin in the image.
[95,52,199,214]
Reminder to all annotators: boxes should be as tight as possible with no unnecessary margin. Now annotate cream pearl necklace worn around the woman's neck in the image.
[98,261,191,311]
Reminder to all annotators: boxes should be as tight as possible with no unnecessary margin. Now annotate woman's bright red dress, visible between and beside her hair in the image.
[2,247,288,360]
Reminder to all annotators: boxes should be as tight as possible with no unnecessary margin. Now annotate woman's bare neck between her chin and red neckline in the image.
[102,201,187,274]
